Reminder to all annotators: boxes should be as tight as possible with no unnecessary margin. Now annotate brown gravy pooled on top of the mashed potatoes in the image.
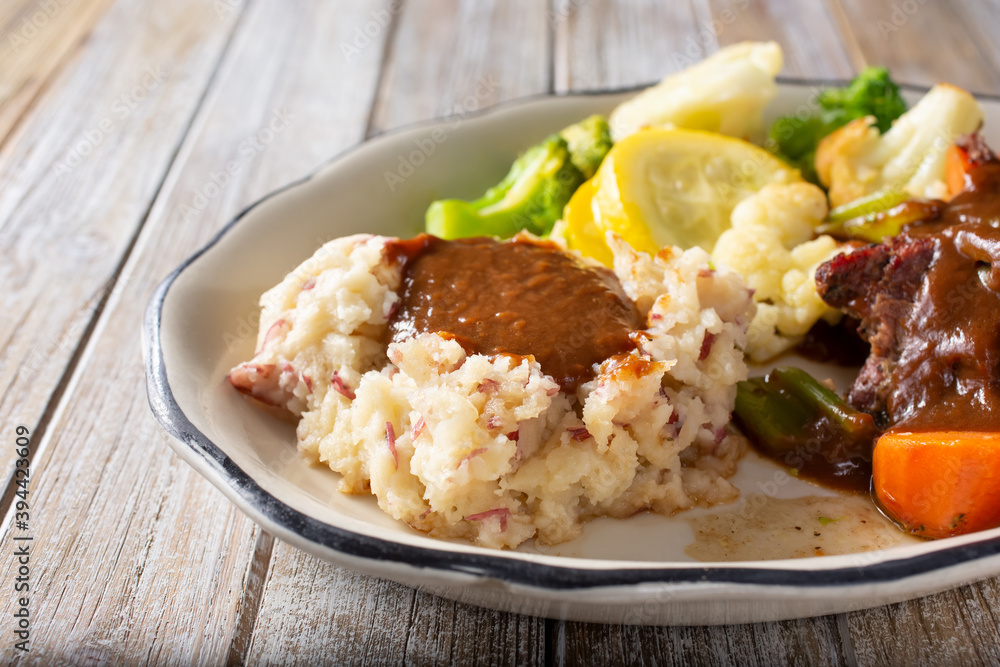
[389,234,642,393]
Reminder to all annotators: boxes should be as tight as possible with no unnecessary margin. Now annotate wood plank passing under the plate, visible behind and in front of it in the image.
[248,0,549,665]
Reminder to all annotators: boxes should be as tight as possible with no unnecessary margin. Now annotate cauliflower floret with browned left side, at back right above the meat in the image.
[816,83,983,206]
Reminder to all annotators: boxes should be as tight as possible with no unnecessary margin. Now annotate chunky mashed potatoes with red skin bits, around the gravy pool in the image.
[230,236,755,547]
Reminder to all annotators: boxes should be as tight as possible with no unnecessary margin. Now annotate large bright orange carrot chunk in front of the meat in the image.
[872,431,1000,538]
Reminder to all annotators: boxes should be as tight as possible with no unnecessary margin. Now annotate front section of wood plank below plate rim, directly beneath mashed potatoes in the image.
[248,543,545,665]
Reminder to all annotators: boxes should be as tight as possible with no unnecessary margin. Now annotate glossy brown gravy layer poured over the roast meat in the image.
[888,161,1000,431]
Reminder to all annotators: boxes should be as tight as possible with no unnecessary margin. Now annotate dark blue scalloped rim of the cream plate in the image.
[142,77,1000,591]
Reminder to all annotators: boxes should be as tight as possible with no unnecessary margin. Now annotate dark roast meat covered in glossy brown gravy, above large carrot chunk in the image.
[816,137,1000,431]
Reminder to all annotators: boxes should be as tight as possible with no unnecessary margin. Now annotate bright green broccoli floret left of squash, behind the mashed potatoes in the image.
[426,134,584,239]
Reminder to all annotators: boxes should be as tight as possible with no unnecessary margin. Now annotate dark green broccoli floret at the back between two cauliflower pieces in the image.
[769,67,906,184]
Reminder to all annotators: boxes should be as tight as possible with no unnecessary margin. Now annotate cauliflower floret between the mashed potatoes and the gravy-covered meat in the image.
[712,183,840,362]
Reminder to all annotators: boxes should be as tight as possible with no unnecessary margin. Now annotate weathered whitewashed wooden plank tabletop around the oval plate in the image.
[0,0,1000,664]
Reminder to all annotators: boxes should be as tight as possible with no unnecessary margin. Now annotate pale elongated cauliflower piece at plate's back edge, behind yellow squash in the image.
[609,42,782,142]
